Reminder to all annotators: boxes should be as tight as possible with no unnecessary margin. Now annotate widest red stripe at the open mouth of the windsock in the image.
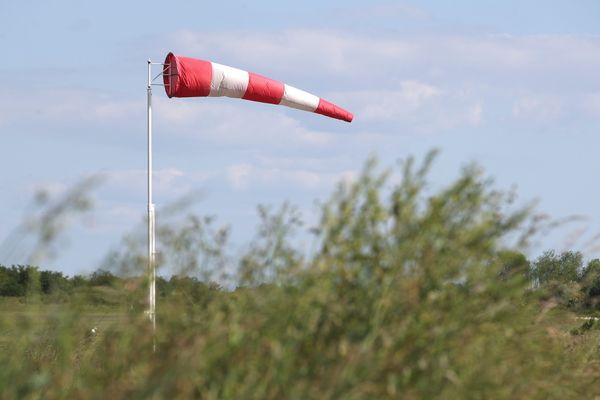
[163,53,212,97]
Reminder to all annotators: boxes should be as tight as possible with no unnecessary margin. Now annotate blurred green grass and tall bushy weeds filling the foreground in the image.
[0,157,600,399]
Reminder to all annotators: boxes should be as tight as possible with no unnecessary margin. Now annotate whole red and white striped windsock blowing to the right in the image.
[163,53,353,122]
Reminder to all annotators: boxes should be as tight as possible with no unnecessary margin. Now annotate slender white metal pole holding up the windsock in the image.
[147,59,156,350]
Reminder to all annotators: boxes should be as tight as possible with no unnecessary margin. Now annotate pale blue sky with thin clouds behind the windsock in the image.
[0,0,600,274]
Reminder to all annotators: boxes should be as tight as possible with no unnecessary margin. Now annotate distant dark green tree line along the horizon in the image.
[0,250,600,311]
